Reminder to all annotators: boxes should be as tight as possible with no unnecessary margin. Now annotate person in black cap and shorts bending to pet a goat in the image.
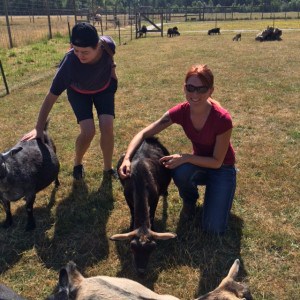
[22,22,118,180]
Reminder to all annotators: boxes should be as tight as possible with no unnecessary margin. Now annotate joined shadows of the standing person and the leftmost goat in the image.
[0,173,114,274]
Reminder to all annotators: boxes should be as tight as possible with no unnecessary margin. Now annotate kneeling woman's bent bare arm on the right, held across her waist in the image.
[160,129,232,169]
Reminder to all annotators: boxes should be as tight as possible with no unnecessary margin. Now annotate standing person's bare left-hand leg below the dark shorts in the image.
[74,119,95,166]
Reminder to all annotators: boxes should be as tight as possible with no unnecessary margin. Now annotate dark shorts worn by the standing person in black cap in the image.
[67,78,118,123]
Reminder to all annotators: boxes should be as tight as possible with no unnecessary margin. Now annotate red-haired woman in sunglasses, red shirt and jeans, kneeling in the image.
[118,65,236,234]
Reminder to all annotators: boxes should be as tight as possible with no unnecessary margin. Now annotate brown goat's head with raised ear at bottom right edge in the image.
[196,259,253,300]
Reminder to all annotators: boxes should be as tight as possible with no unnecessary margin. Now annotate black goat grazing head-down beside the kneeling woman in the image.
[110,138,176,273]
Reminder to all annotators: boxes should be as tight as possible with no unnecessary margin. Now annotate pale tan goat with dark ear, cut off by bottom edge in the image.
[47,261,179,300]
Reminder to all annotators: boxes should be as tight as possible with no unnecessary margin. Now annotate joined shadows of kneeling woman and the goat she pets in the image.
[112,198,247,298]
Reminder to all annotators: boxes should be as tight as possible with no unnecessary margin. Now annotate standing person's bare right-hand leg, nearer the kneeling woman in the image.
[99,115,114,171]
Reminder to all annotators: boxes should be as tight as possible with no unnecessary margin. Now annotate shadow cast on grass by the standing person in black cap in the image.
[37,178,114,271]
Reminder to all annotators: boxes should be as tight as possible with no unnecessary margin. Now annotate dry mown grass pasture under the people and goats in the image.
[0,22,300,300]
